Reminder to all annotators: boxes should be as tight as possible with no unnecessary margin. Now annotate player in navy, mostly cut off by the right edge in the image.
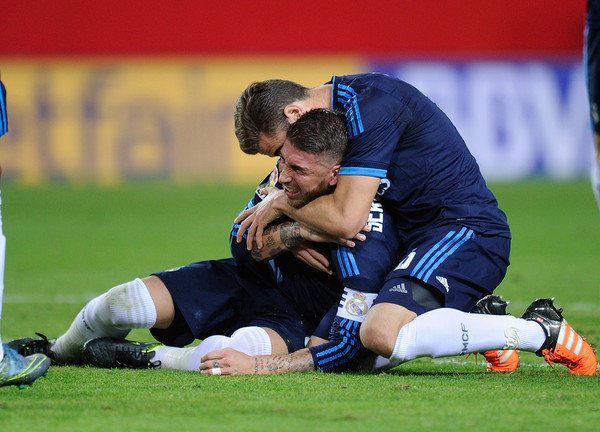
[584,0,600,207]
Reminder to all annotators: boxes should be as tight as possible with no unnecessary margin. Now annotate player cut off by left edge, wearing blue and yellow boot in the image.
[0,80,50,387]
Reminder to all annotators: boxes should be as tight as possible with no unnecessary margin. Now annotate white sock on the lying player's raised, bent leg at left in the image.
[51,279,156,363]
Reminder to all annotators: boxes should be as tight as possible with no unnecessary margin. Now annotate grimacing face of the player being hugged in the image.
[279,141,339,208]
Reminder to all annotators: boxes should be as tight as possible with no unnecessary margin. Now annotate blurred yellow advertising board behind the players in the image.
[0,57,363,185]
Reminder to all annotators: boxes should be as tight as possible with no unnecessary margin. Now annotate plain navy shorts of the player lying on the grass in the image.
[151,258,306,352]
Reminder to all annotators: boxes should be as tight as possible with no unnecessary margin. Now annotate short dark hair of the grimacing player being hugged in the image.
[286,108,348,165]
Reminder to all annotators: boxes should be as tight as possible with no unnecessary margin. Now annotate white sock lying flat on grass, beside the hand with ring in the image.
[157,327,271,371]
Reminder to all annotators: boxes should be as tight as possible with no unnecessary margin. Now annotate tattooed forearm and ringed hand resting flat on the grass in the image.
[200,348,315,375]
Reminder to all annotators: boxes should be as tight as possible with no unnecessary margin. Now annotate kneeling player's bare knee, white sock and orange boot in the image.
[361,292,598,375]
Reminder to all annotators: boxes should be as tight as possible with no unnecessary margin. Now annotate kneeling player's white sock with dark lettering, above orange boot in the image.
[390,308,545,362]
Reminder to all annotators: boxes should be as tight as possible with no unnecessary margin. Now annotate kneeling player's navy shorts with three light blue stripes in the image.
[374,225,510,315]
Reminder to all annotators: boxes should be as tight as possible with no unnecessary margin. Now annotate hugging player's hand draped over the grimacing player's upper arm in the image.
[235,188,286,250]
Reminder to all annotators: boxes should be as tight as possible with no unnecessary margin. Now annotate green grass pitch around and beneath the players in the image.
[0,181,600,432]
